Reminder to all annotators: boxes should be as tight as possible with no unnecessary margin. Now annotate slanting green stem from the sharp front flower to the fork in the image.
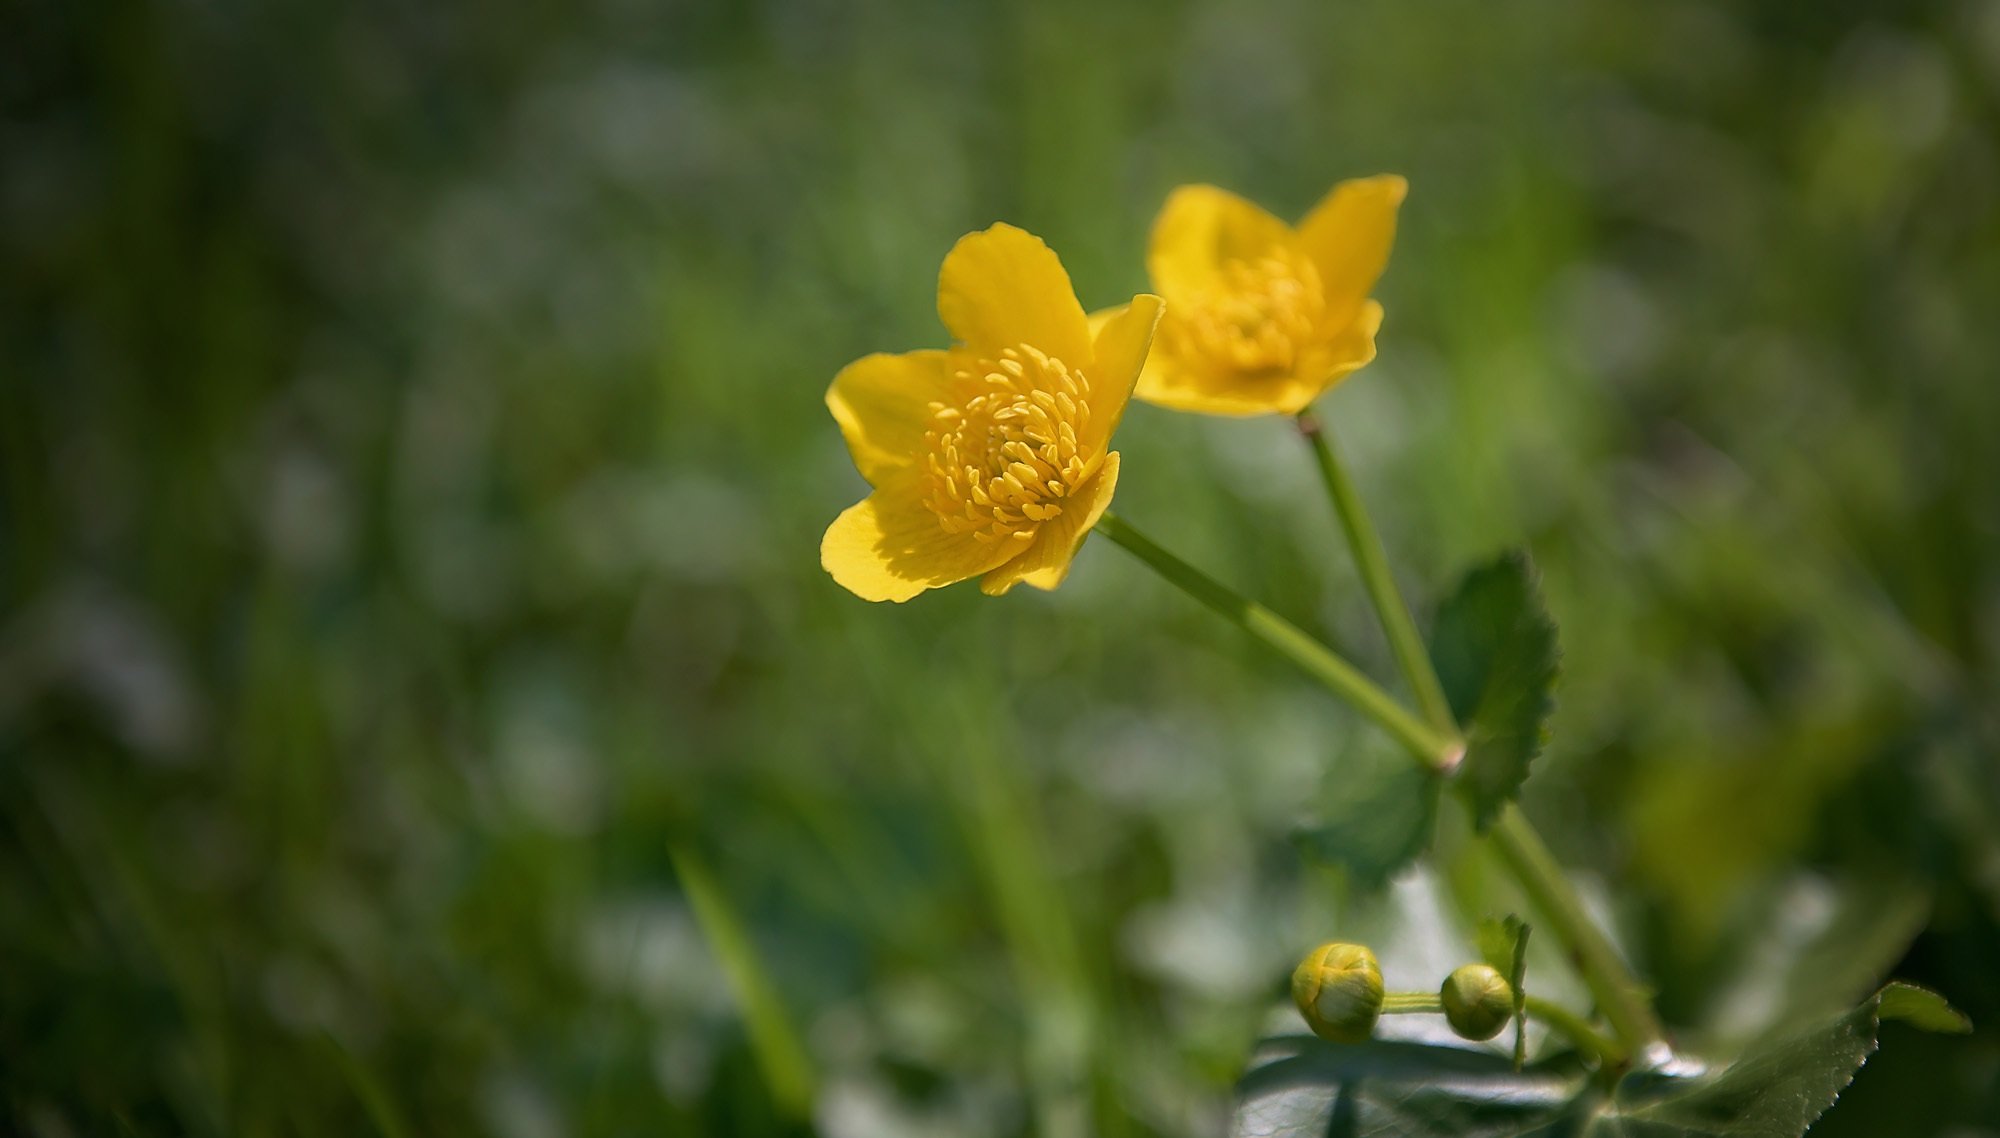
[1096,512,1464,770]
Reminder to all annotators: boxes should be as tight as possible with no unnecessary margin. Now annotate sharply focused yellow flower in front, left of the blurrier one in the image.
[820,224,1160,600]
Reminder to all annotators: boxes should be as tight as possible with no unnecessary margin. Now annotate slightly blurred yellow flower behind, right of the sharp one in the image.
[1094,174,1408,414]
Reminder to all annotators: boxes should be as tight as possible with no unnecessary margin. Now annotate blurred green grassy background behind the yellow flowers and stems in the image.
[0,0,2000,1138]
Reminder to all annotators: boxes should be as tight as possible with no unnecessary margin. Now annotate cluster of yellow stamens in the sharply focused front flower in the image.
[924,344,1092,542]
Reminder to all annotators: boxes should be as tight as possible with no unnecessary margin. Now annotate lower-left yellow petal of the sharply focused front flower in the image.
[820,472,1030,600]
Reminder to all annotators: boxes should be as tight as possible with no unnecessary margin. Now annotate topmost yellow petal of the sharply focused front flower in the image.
[938,222,1090,366]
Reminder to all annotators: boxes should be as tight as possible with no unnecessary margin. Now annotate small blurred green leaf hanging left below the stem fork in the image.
[1292,734,1440,892]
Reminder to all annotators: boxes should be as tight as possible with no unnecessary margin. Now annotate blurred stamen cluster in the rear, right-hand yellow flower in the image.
[1160,248,1326,374]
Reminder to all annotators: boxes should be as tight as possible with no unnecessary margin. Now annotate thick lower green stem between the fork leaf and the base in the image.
[1486,802,1662,1054]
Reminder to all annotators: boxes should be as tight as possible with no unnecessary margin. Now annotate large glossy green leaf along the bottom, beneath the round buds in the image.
[1230,980,1968,1138]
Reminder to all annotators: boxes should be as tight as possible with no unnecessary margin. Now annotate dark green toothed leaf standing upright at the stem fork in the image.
[1430,550,1558,832]
